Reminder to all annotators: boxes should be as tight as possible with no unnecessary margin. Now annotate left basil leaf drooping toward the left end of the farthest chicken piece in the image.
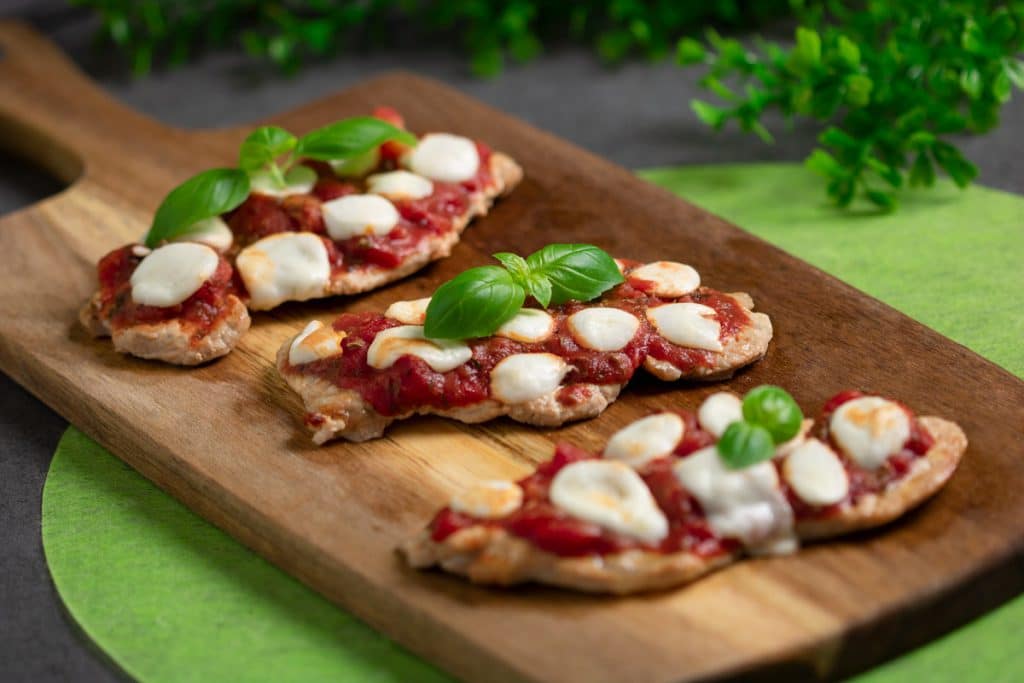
[144,168,249,249]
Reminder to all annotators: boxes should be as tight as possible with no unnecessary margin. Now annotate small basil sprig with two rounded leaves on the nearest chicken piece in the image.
[718,384,804,469]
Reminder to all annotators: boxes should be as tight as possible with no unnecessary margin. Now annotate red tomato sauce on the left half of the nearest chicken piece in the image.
[430,432,738,557]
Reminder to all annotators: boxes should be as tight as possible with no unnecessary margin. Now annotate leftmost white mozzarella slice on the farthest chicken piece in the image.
[130,242,220,308]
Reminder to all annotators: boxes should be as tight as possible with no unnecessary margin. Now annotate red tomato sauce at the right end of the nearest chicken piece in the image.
[780,390,935,518]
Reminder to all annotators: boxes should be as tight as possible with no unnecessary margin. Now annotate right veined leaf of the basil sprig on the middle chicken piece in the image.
[526,244,623,305]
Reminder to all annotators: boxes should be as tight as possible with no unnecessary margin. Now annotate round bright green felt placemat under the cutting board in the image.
[43,164,1024,683]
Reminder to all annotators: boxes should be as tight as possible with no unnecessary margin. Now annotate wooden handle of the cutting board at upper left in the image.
[0,20,161,183]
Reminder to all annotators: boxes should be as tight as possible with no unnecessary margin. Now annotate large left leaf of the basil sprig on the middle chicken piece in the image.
[423,265,526,339]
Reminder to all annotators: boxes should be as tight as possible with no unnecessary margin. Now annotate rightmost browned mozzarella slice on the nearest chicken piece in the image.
[828,396,910,470]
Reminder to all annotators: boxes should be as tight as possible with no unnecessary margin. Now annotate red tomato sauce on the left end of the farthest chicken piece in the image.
[91,245,234,343]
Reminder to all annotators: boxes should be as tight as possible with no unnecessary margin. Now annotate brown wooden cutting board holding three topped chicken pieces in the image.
[0,23,1024,682]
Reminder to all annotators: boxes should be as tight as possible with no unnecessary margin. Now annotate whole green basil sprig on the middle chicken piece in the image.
[423,245,623,339]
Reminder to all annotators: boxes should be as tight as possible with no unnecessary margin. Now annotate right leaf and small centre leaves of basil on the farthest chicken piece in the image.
[239,116,416,187]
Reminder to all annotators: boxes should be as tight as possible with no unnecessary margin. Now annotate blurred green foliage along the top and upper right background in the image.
[71,0,1024,210]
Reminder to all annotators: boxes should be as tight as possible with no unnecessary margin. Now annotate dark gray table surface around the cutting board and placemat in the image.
[0,0,1024,681]
